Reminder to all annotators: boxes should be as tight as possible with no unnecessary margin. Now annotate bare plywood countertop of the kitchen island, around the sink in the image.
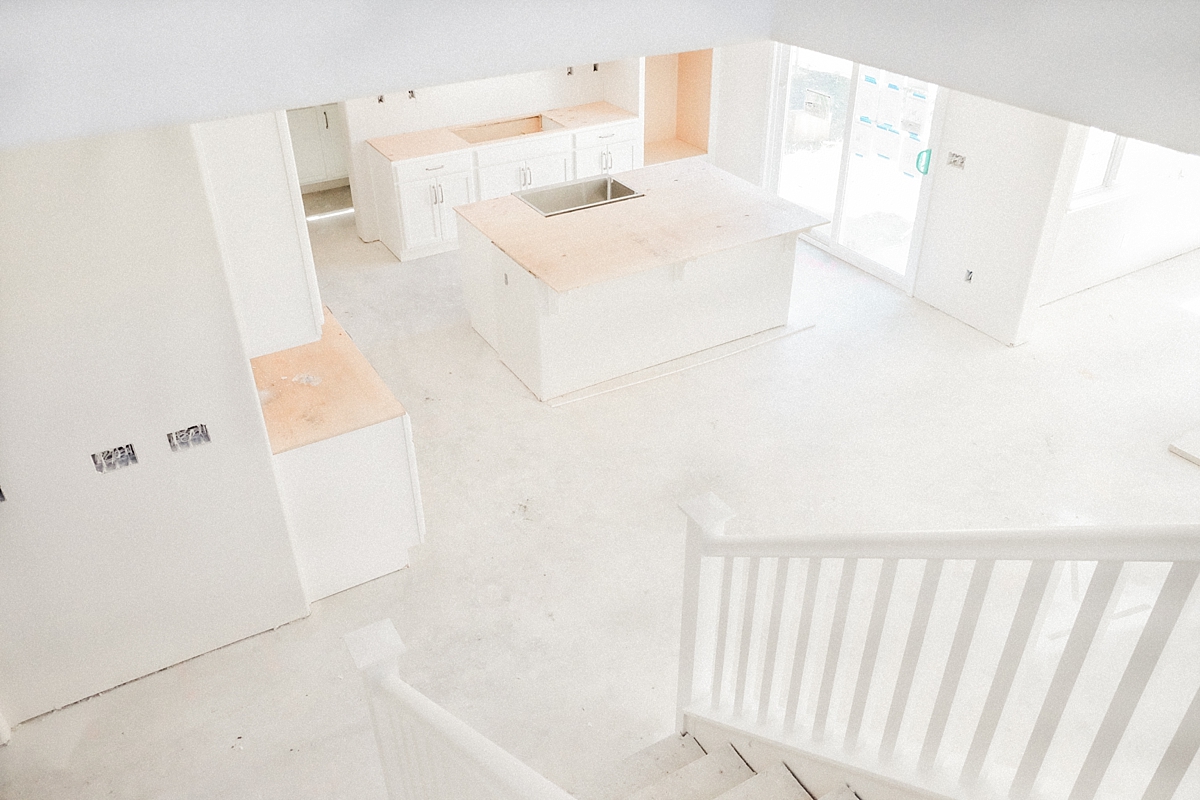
[455,158,828,291]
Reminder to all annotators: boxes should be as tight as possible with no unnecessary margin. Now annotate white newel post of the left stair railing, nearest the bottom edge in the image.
[342,619,407,798]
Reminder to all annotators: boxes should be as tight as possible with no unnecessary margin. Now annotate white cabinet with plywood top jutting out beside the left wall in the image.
[251,308,425,601]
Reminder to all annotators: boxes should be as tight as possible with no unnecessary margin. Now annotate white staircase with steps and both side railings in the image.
[346,494,1200,800]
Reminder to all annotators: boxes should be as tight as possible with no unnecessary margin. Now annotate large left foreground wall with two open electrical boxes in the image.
[0,126,306,723]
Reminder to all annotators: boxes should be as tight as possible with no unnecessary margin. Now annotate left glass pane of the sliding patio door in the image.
[779,47,854,241]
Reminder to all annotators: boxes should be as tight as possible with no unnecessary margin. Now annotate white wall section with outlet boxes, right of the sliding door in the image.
[914,91,1069,344]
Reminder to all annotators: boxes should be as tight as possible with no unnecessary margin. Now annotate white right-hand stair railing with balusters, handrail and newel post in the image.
[677,493,1200,800]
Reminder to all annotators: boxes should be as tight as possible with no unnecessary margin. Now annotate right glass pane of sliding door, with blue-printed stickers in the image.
[838,65,936,275]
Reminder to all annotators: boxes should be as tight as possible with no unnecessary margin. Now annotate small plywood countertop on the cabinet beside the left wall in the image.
[250,308,404,453]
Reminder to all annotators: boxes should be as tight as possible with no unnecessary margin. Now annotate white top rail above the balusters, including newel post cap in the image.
[679,493,1200,561]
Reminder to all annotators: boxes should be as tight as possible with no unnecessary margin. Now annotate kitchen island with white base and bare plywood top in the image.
[455,158,827,401]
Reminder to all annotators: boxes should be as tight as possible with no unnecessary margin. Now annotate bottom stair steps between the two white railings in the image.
[575,734,825,800]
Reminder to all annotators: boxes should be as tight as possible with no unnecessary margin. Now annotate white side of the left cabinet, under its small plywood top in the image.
[275,414,425,602]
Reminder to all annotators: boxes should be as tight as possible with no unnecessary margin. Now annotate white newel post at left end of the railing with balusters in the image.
[676,492,737,733]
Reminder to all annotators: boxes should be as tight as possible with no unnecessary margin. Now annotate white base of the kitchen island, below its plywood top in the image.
[458,222,797,401]
